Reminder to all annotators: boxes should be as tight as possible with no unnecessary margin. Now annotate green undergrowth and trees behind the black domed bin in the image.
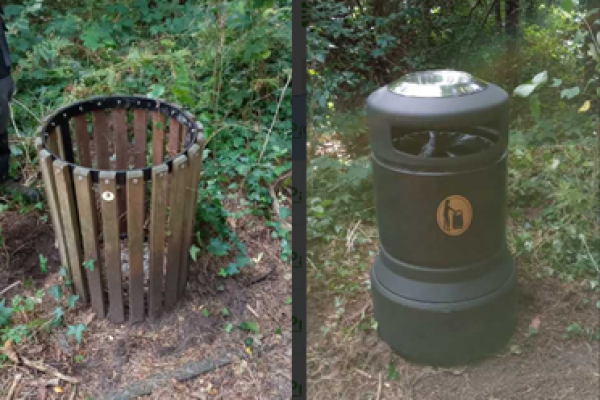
[308,1,600,288]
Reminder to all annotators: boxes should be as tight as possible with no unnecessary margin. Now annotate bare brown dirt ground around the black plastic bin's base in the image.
[307,250,600,400]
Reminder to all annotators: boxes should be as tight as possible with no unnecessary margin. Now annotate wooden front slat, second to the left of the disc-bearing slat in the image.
[54,160,89,303]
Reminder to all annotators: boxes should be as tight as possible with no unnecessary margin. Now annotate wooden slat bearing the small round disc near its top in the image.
[99,171,125,323]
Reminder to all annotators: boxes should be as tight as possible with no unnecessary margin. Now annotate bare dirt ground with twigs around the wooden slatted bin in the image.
[0,202,292,400]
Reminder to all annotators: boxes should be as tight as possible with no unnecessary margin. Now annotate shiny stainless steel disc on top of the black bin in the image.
[388,70,488,98]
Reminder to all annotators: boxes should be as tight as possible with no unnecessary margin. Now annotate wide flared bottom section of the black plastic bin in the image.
[370,257,517,366]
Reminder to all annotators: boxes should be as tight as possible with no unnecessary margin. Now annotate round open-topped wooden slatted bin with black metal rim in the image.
[36,96,204,323]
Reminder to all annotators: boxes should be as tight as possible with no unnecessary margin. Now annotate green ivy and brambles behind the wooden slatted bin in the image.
[4,0,291,276]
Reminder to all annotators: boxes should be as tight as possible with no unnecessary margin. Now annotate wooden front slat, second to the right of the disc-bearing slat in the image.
[148,164,169,318]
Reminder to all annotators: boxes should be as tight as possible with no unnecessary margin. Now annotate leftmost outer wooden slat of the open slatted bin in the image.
[36,143,69,270]
